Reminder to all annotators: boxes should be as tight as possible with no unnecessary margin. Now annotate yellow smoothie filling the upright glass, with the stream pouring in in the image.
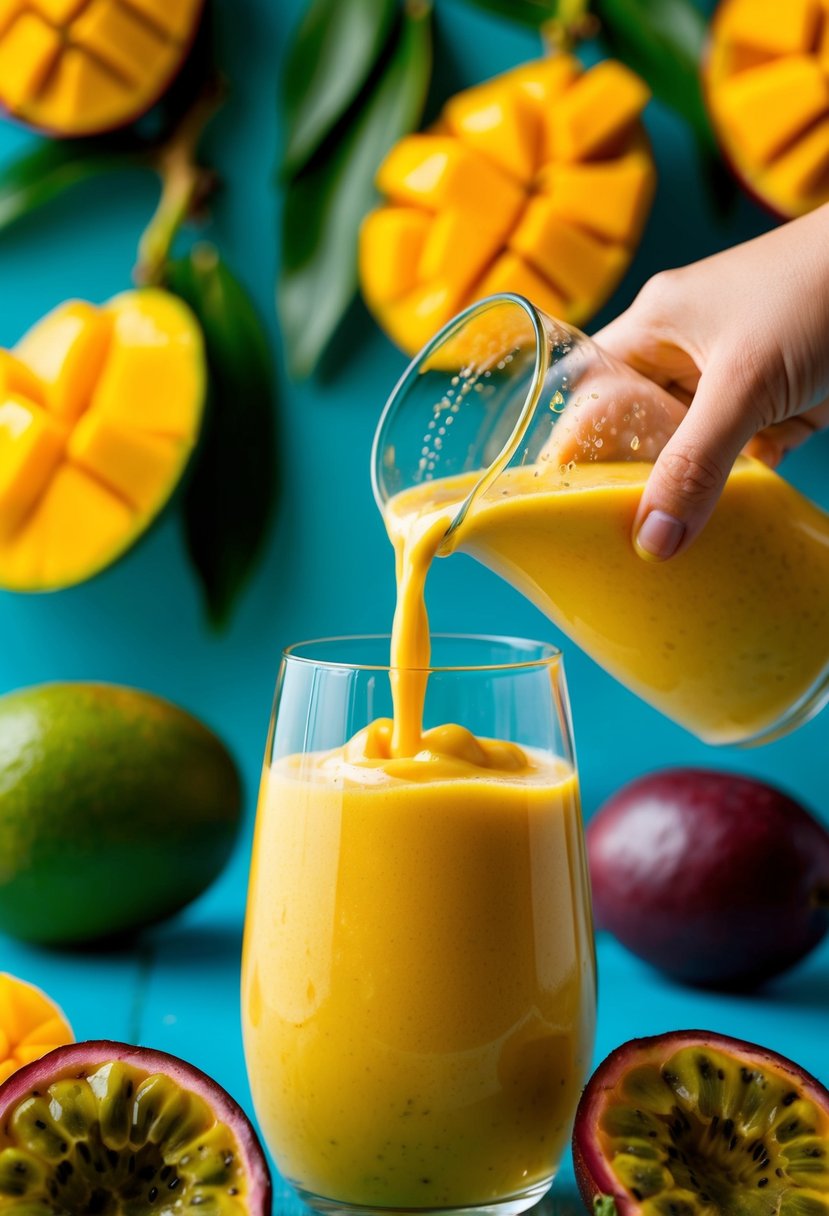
[243,457,596,1210]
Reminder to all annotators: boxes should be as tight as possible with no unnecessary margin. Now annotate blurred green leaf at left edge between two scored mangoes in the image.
[0,140,140,232]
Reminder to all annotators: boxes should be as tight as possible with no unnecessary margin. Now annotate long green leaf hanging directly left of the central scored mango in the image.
[277,7,432,377]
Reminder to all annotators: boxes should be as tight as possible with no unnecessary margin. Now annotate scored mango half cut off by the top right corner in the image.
[705,0,829,219]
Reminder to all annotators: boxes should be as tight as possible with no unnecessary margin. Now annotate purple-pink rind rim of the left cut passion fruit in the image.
[0,1038,272,1216]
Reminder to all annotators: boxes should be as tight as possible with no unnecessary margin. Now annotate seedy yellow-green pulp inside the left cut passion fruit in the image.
[0,1060,248,1216]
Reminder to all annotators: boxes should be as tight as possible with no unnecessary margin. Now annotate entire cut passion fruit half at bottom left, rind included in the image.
[0,1041,271,1216]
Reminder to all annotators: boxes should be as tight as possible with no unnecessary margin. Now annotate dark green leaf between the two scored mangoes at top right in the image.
[593,0,714,146]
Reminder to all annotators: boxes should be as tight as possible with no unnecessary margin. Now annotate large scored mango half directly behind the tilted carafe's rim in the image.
[360,55,655,354]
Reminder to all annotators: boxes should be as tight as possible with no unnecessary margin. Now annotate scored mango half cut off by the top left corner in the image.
[0,0,203,136]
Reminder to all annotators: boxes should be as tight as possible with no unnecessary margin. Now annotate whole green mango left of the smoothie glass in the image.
[0,683,242,945]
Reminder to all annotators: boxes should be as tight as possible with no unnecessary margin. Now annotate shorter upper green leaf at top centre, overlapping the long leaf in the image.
[282,0,397,178]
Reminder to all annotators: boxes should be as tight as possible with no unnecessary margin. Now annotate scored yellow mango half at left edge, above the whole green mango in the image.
[0,288,205,591]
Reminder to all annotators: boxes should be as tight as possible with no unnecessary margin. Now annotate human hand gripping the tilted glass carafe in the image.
[594,206,829,561]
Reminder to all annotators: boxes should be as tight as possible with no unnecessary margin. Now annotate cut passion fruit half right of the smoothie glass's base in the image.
[573,1030,829,1216]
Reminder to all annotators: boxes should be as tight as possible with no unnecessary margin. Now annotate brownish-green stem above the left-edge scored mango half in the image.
[132,73,226,287]
